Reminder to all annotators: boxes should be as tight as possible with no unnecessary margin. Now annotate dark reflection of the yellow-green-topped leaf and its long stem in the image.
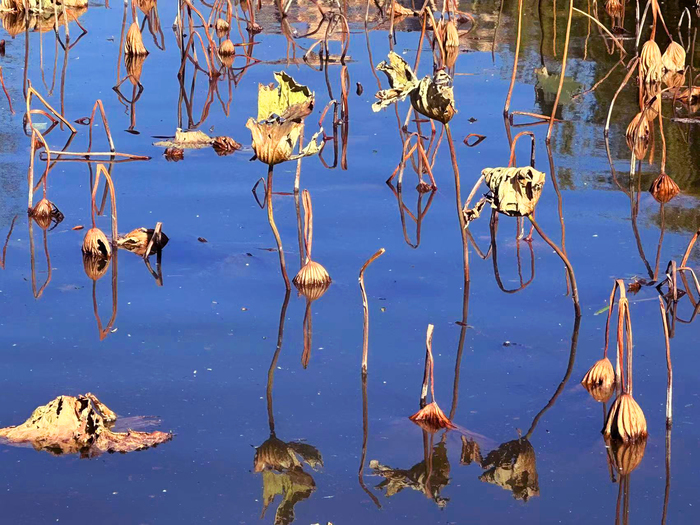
[253,290,323,525]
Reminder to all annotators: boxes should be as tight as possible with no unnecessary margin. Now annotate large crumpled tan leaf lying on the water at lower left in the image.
[0,394,173,457]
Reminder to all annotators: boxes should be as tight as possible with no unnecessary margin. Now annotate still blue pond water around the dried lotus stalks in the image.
[0,0,700,525]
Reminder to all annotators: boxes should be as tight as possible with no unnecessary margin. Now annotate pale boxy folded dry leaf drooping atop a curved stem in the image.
[481,166,545,217]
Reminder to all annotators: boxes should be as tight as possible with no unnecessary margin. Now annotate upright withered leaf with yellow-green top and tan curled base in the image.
[246,72,323,165]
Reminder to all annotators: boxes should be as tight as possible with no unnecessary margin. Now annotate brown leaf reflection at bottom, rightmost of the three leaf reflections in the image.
[479,439,540,501]
